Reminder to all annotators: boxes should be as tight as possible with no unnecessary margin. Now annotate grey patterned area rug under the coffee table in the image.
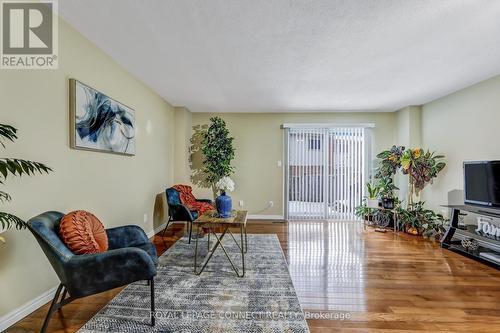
[78,235,309,333]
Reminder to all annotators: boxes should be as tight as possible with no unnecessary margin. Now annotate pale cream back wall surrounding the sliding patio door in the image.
[192,112,396,216]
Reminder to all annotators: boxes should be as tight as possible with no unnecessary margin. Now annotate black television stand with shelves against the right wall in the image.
[441,205,500,269]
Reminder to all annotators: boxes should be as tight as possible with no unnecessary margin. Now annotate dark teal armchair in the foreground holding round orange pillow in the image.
[28,212,158,333]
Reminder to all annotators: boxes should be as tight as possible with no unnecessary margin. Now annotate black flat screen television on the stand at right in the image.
[464,161,500,208]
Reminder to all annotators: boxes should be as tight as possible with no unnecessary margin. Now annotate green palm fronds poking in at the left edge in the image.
[0,124,52,242]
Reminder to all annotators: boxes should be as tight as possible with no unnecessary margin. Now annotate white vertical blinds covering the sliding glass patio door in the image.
[287,127,365,219]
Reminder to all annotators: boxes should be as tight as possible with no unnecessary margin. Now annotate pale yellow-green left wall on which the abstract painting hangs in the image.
[0,16,174,317]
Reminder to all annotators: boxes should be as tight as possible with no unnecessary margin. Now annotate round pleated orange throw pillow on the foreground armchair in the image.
[59,210,108,254]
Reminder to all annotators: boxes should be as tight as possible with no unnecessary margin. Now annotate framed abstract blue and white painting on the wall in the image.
[70,79,136,155]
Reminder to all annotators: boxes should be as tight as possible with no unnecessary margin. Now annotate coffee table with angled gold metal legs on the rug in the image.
[193,210,248,277]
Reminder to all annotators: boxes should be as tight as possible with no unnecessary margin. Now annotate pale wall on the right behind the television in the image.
[422,76,500,210]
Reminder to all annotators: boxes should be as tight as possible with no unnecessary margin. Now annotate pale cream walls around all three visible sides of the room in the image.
[4,7,500,324]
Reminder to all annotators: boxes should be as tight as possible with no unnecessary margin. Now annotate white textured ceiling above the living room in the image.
[59,0,500,112]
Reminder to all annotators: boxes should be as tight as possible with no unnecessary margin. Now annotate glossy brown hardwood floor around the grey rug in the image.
[6,221,500,333]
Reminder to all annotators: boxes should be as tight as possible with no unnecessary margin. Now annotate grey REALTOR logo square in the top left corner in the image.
[0,0,58,69]
